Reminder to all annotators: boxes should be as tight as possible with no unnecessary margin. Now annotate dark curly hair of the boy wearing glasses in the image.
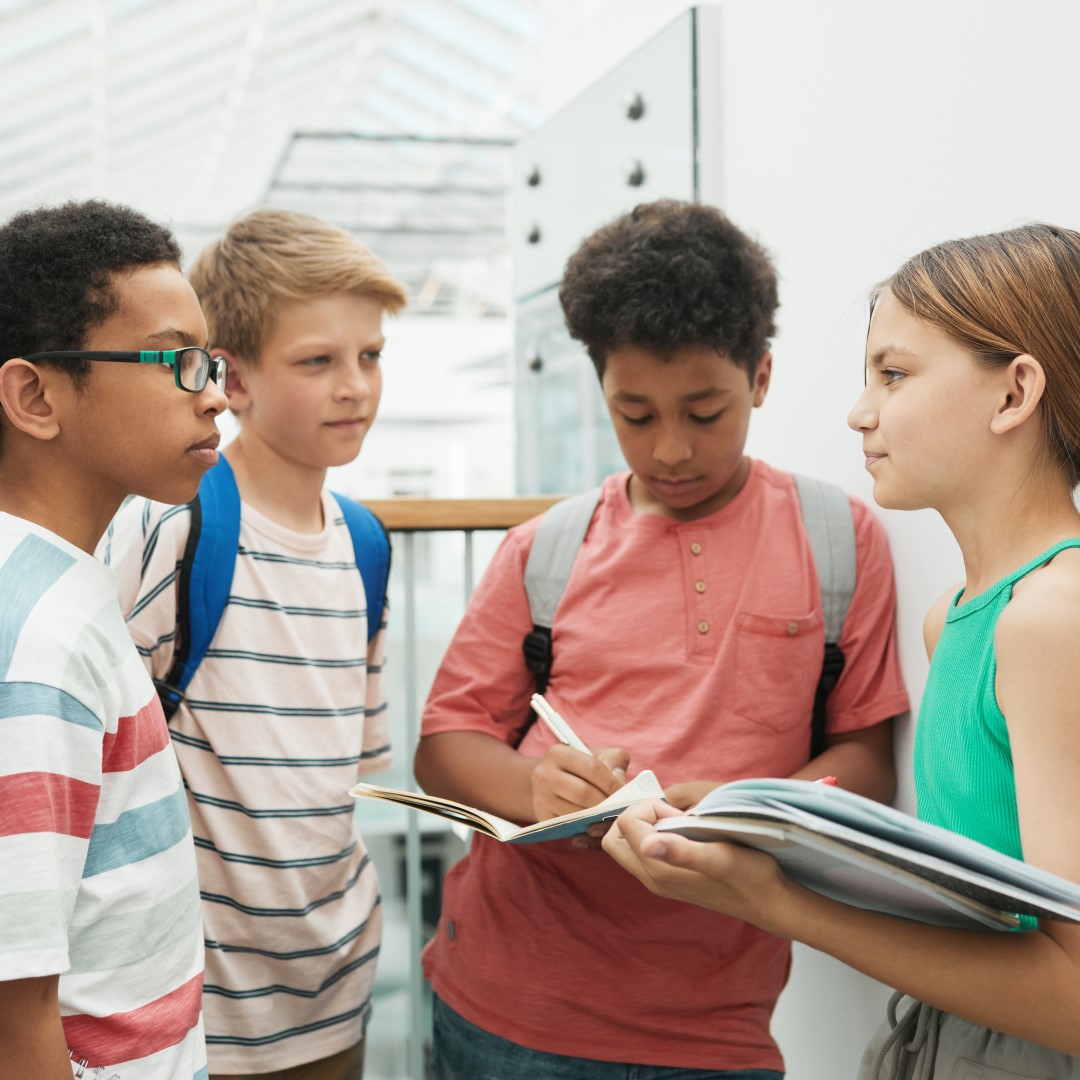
[0,199,180,386]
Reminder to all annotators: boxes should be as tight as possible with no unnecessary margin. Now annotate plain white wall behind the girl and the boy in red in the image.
[529,0,1080,1080]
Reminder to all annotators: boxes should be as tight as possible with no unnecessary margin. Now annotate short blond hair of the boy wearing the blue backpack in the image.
[188,210,408,363]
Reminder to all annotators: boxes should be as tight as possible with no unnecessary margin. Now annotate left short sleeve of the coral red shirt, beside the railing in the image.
[420,525,536,743]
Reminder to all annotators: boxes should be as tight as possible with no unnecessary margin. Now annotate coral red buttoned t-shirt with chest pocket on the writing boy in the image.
[422,461,908,1069]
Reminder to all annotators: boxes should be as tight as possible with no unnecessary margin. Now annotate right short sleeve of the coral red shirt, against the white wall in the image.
[826,499,910,732]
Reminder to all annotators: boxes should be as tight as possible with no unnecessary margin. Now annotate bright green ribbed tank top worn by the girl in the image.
[915,538,1080,859]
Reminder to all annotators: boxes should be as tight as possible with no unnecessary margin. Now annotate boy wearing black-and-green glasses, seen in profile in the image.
[0,201,226,1080]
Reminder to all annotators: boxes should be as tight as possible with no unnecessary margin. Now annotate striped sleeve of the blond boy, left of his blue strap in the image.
[97,498,191,678]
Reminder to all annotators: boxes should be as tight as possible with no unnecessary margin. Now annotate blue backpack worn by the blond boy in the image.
[154,456,390,719]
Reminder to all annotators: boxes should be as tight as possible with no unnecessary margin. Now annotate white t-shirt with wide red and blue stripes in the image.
[0,513,207,1080]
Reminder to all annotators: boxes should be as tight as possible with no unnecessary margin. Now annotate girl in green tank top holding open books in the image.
[604,225,1080,1080]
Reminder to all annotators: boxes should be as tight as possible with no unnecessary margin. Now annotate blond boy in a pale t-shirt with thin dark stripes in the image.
[106,210,405,1080]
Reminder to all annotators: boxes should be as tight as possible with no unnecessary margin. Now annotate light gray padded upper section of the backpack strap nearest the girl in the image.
[794,474,855,644]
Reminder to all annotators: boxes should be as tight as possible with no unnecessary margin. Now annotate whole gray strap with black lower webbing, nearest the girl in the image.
[794,474,855,758]
